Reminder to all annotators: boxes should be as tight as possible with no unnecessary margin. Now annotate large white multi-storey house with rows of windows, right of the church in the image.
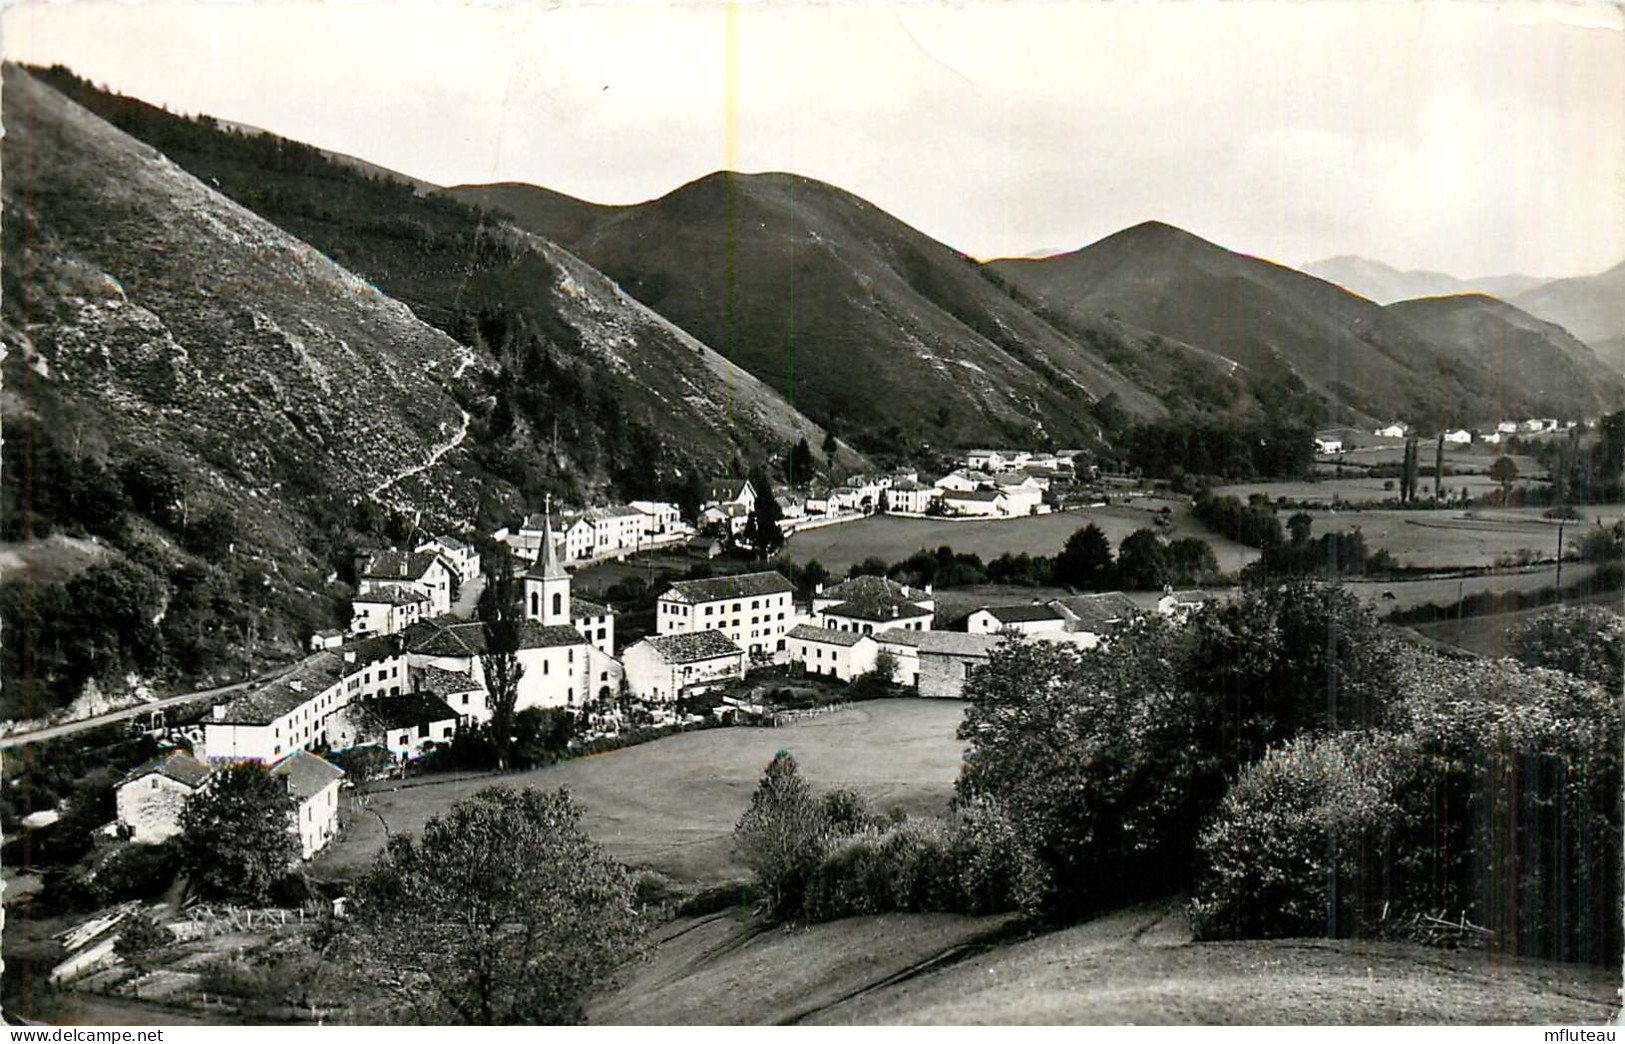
[655,571,795,659]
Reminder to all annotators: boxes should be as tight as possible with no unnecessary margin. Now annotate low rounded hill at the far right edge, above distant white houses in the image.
[1388,294,1625,420]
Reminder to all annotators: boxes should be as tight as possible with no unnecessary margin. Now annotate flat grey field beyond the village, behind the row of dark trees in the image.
[787,498,1258,574]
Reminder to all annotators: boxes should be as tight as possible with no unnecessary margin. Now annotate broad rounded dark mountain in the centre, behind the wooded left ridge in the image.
[450,172,1230,450]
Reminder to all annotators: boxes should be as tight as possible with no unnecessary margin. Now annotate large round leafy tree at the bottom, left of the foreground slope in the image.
[354,787,642,1026]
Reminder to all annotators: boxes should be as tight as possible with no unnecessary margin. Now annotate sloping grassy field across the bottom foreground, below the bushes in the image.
[588,901,1619,1024]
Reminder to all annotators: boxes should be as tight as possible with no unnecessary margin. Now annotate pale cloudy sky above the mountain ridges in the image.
[0,0,1625,278]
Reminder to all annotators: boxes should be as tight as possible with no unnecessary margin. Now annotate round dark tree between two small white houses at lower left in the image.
[179,761,299,906]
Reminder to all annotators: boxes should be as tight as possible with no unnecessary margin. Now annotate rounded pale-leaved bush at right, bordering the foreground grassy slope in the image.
[1191,737,1404,938]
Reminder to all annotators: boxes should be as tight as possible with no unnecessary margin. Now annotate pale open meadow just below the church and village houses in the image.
[315,699,964,885]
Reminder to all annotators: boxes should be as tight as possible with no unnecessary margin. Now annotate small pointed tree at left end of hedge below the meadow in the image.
[733,750,827,917]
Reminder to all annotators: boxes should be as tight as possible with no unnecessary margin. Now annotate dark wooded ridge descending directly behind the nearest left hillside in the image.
[25,68,863,507]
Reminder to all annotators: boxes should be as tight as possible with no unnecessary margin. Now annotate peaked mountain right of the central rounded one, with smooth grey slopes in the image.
[988,221,1547,423]
